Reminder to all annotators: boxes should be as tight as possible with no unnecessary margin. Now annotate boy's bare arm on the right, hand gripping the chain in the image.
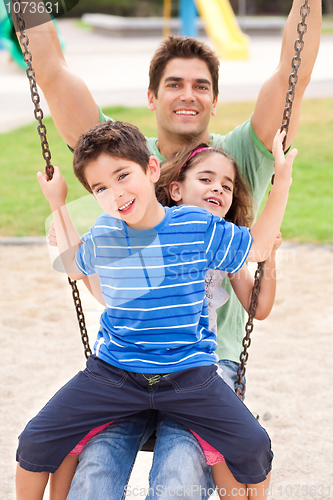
[247,130,297,262]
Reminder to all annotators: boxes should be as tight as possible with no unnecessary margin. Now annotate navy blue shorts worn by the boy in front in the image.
[17,356,273,484]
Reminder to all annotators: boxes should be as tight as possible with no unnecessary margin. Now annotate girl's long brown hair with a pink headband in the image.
[156,143,254,227]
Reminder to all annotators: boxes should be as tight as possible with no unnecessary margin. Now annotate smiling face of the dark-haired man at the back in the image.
[148,58,217,144]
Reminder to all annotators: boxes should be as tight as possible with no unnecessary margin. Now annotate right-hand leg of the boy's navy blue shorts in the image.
[154,366,273,484]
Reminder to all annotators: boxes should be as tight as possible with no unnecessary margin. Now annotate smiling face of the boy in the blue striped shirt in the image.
[84,154,164,229]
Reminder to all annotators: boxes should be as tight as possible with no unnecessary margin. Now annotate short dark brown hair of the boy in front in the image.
[73,121,150,193]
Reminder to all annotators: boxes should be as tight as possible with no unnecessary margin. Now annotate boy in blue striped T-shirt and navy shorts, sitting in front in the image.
[17,122,296,500]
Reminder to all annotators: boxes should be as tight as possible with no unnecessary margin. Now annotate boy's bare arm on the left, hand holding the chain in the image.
[37,167,86,280]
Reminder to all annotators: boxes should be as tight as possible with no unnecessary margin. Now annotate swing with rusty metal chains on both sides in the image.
[13,0,310,451]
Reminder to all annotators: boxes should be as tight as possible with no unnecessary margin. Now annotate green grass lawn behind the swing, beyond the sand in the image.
[0,99,333,244]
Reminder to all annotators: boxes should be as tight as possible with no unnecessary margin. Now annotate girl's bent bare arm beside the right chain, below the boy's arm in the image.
[229,233,282,320]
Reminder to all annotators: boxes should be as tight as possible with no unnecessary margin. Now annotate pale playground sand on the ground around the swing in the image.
[0,240,333,500]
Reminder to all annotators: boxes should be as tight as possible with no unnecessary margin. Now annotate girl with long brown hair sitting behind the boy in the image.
[49,139,281,500]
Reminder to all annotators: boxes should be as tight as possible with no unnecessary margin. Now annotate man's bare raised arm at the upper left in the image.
[13,2,99,148]
